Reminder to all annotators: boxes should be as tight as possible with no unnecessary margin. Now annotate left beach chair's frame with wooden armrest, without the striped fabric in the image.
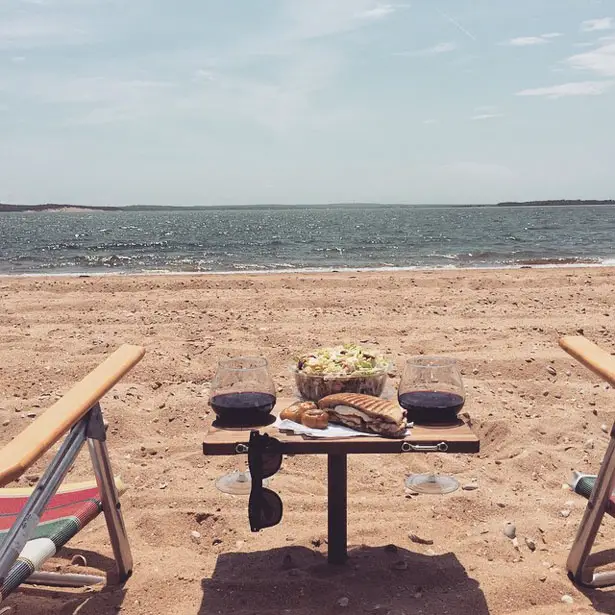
[0,345,144,587]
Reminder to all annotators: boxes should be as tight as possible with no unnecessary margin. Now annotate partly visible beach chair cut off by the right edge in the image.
[560,336,615,587]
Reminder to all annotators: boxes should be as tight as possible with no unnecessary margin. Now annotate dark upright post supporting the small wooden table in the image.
[327,454,347,564]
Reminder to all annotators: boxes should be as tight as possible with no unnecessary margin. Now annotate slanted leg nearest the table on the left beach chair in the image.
[88,404,133,584]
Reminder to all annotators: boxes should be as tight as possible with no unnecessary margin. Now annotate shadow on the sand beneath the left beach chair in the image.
[7,547,126,615]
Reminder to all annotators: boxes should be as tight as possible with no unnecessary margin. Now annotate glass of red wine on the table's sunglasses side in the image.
[209,357,276,495]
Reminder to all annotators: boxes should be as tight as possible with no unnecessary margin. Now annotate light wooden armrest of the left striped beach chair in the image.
[0,344,145,487]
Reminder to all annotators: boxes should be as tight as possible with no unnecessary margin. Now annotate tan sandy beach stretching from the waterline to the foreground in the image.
[0,268,615,615]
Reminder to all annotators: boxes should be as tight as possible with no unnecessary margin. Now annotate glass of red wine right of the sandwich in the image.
[397,356,465,494]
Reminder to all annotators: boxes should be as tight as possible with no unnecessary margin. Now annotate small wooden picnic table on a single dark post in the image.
[203,399,480,564]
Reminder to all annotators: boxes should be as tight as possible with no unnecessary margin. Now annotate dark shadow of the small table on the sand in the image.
[198,545,489,615]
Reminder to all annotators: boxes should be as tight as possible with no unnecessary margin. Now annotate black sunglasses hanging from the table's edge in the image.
[248,431,283,532]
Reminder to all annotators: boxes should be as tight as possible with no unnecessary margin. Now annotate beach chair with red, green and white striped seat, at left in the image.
[0,345,145,603]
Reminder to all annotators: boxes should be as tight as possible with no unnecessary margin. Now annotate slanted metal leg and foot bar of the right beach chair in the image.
[566,425,615,587]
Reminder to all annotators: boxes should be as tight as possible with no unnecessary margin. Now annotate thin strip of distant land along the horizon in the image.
[0,199,615,213]
